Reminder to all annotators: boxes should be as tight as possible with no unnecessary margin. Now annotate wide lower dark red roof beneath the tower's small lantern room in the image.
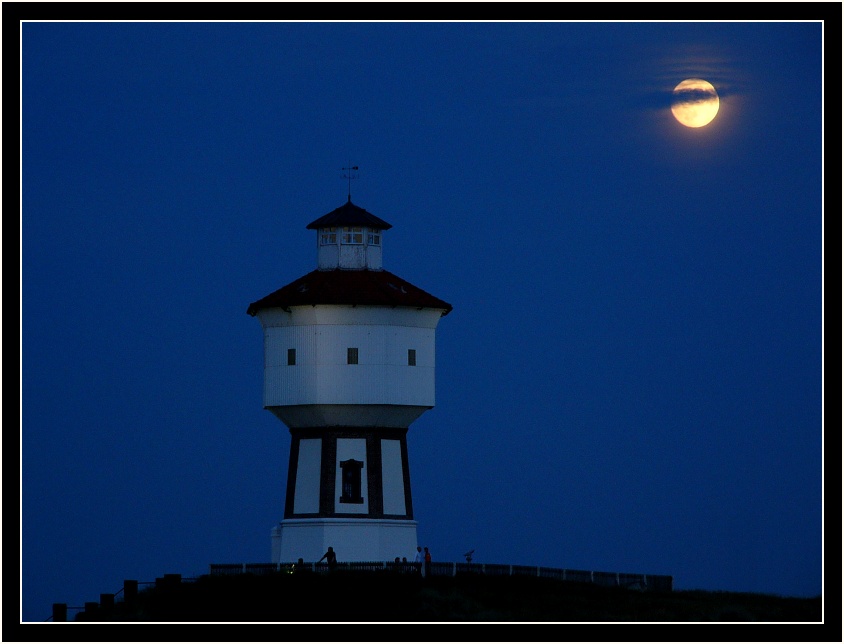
[246,268,452,316]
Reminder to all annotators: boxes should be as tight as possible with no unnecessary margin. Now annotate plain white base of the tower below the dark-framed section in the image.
[271,518,417,563]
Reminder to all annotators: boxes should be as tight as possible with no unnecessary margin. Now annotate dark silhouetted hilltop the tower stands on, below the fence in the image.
[69,571,822,623]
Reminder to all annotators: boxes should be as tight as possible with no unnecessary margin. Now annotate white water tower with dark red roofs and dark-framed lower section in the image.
[247,197,452,562]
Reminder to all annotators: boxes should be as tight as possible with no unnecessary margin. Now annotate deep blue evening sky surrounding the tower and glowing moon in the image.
[21,22,823,621]
